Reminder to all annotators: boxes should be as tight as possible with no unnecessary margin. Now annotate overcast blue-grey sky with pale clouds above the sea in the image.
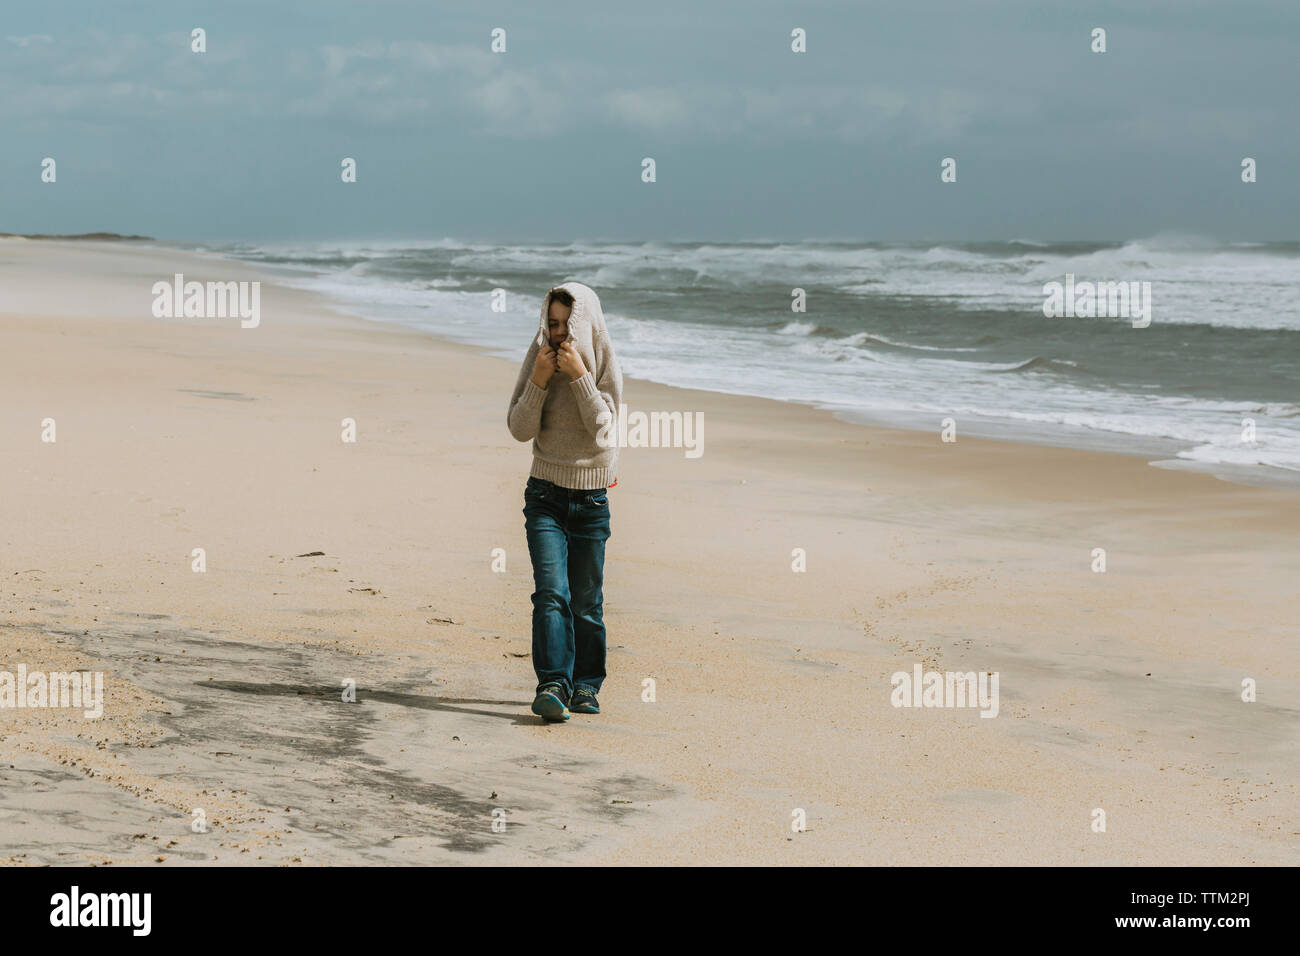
[0,0,1300,242]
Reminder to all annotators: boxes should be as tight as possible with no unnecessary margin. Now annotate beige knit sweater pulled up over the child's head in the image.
[506,282,623,490]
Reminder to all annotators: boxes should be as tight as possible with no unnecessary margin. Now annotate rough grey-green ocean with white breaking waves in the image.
[191,235,1300,484]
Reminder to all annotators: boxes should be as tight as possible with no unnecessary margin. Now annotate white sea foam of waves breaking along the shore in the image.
[205,237,1300,471]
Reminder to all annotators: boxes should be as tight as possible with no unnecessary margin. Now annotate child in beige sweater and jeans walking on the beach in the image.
[506,282,623,722]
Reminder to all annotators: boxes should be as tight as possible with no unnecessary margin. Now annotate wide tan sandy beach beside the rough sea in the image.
[0,239,1300,865]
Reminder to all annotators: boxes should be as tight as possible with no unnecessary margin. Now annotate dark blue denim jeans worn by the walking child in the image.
[524,477,610,695]
